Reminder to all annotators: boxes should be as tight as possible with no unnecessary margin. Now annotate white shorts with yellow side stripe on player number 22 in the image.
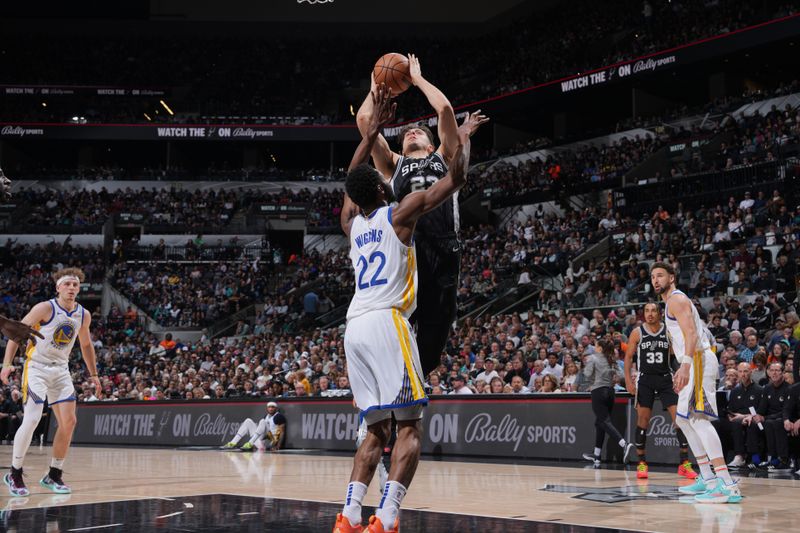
[344,309,428,425]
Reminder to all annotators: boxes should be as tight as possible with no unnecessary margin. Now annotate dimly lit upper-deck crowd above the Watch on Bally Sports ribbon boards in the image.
[0,0,796,123]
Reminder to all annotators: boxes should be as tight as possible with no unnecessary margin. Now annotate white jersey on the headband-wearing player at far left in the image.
[25,299,85,365]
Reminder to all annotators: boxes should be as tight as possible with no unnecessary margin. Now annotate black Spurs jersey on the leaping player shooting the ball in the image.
[392,152,459,238]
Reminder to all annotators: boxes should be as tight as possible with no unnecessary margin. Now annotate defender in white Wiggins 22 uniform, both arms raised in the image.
[333,86,469,533]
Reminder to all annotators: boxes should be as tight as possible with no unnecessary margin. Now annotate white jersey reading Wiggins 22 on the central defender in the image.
[347,206,417,320]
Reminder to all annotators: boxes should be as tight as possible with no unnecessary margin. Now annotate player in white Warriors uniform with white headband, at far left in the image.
[0,268,100,496]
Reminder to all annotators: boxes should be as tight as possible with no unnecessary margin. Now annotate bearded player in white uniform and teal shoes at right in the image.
[650,262,742,503]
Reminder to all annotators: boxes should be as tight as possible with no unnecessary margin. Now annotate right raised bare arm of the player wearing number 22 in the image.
[392,127,470,242]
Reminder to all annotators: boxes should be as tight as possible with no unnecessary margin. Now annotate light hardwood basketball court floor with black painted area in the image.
[0,446,800,533]
